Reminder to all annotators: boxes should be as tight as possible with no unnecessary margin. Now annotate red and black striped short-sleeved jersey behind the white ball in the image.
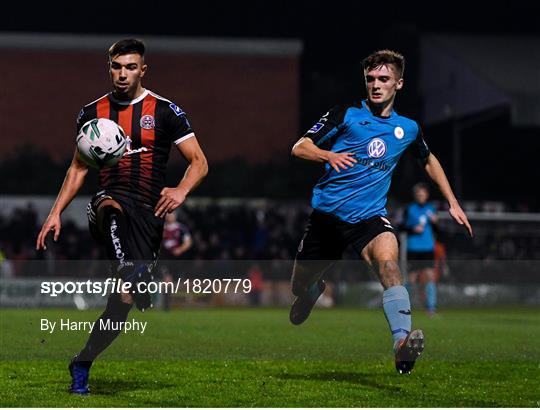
[77,90,195,208]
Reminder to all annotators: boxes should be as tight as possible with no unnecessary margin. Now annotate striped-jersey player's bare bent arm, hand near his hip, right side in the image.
[155,136,208,218]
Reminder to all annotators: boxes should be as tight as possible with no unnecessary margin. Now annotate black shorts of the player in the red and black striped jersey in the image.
[86,191,164,261]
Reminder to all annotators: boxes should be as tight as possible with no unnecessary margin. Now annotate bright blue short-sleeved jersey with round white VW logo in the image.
[304,101,430,223]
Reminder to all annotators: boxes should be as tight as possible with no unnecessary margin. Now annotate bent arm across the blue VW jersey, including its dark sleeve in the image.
[291,107,357,172]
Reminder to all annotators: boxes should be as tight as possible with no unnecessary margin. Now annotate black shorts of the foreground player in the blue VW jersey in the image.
[296,210,398,260]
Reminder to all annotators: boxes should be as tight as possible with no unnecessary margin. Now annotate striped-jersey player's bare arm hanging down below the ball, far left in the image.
[36,150,88,250]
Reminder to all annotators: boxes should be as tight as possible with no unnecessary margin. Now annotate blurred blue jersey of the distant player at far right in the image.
[405,203,436,252]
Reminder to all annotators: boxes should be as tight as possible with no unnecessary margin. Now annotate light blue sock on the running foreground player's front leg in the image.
[383,286,411,346]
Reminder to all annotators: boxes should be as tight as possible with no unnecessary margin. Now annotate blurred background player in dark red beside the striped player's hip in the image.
[160,211,193,310]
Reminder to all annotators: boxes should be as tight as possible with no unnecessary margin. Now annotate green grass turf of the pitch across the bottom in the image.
[0,308,540,407]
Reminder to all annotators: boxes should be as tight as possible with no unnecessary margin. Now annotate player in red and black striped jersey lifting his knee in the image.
[36,39,208,394]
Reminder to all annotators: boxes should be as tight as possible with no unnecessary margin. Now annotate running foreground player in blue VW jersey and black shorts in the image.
[290,50,472,374]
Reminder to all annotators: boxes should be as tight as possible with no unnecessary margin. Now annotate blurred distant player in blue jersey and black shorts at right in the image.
[405,183,437,315]
